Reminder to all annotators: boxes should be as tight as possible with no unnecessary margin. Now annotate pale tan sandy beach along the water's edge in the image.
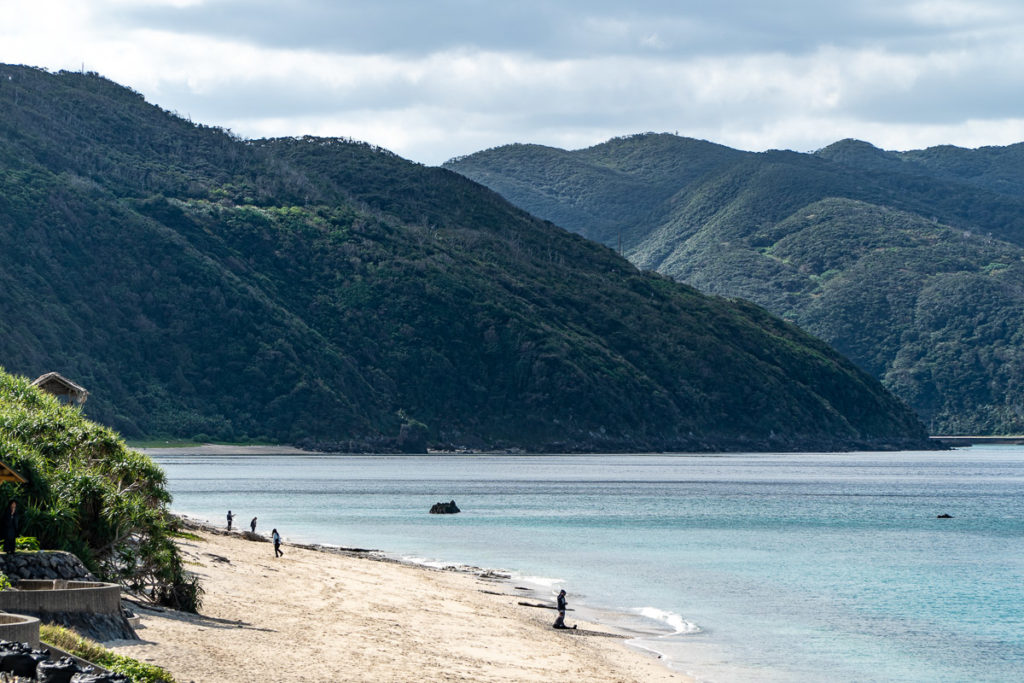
[113,531,691,683]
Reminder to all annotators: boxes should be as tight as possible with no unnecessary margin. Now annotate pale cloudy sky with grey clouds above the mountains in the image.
[0,0,1024,164]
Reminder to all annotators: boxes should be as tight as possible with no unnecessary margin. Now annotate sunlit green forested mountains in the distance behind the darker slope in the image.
[445,133,1024,434]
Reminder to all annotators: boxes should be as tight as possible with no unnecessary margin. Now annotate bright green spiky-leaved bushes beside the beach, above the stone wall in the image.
[0,369,202,610]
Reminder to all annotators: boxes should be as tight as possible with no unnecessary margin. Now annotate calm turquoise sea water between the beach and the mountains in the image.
[150,446,1024,683]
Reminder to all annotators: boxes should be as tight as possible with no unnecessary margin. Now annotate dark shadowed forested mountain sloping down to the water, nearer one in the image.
[0,66,925,451]
